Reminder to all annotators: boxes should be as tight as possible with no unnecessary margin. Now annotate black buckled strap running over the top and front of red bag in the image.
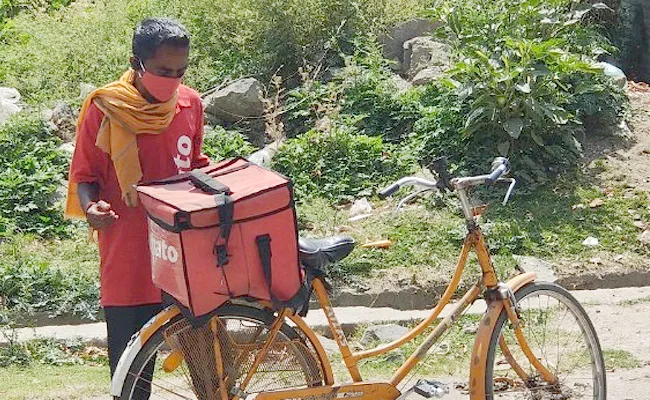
[190,169,235,267]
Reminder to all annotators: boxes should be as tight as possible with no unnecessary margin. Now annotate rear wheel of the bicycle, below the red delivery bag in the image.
[120,304,323,400]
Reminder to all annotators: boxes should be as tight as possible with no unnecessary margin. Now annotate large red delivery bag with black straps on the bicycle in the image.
[137,158,302,317]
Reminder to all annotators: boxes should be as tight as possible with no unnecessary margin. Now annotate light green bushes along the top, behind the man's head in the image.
[0,0,422,103]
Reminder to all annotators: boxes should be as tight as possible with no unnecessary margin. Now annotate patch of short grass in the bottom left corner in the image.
[0,364,110,400]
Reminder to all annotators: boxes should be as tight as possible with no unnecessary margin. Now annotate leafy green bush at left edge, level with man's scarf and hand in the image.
[0,113,69,236]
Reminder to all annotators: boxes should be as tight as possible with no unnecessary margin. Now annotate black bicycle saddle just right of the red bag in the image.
[298,236,355,270]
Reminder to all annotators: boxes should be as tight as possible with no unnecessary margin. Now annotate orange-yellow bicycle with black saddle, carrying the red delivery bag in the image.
[111,158,606,400]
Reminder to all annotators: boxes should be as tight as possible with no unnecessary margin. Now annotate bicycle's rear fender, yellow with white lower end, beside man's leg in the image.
[111,305,180,398]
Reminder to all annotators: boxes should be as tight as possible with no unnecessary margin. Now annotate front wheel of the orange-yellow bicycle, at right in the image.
[485,283,607,400]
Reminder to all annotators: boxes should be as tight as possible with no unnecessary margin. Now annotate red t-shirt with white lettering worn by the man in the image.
[70,85,209,306]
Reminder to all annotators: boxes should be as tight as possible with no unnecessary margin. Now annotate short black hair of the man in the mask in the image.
[132,18,190,62]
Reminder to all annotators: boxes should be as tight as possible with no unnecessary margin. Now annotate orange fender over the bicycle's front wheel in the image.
[469,272,537,400]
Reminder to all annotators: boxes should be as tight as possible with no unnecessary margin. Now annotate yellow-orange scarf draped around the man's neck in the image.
[65,69,177,219]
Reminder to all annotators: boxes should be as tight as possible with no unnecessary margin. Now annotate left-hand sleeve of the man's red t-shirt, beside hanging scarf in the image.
[70,104,110,186]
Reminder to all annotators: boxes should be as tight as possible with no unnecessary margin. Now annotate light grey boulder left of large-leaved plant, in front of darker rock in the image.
[402,36,451,79]
